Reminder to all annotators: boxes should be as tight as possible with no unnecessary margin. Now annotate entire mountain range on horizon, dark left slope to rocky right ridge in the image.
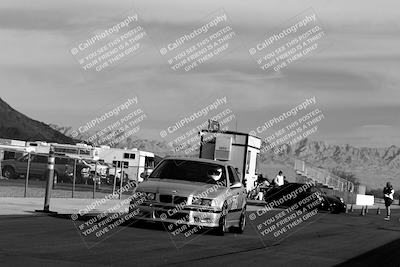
[0,98,400,188]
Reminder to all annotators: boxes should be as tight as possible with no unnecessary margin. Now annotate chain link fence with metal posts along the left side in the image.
[0,149,134,199]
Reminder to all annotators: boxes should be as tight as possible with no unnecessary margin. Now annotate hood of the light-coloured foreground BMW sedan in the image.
[137,179,228,198]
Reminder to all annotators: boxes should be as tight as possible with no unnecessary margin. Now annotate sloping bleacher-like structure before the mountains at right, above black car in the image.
[294,159,354,192]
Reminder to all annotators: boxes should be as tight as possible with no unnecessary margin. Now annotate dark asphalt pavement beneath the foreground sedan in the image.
[0,210,400,267]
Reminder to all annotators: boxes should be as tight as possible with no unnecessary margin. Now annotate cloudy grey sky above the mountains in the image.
[0,0,400,147]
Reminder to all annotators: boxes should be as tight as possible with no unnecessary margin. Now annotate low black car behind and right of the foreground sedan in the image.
[263,183,346,213]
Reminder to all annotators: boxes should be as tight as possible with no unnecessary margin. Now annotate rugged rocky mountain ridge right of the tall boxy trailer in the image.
[262,139,400,191]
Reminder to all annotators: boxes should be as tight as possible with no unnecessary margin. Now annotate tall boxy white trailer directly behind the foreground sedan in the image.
[199,130,261,191]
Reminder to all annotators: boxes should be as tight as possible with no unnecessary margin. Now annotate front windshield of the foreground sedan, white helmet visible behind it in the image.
[149,160,226,186]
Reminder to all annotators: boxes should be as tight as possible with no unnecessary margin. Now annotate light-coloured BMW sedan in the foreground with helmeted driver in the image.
[129,158,246,235]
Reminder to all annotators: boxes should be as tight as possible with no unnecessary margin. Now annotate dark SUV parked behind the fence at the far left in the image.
[1,154,73,181]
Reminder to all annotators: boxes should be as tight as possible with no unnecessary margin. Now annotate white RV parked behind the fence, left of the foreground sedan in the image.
[99,146,154,182]
